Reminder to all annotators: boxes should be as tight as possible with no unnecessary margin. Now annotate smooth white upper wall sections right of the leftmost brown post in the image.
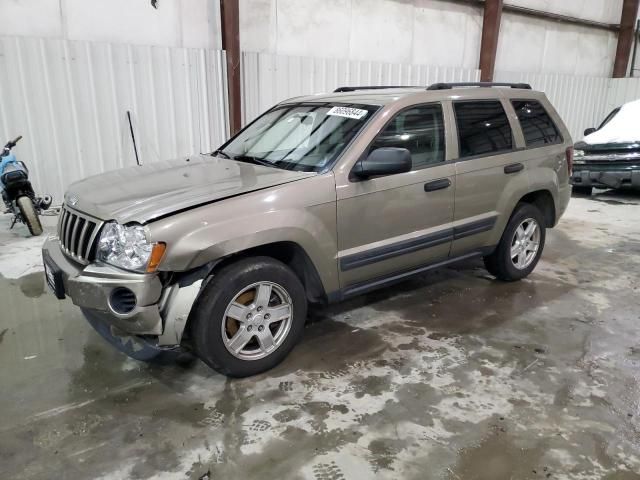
[240,0,622,76]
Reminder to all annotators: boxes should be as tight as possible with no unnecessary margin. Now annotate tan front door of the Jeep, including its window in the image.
[337,103,455,288]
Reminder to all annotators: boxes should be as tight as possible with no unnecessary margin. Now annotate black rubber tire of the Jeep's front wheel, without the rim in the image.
[189,257,307,377]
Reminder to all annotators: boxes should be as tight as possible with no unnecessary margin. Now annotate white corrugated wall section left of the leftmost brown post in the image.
[0,37,229,203]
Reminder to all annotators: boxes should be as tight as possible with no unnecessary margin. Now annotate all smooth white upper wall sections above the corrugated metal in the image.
[0,0,622,76]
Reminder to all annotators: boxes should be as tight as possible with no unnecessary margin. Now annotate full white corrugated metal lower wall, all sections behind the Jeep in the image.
[0,36,640,203]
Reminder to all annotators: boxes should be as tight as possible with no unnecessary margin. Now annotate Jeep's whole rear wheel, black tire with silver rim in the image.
[484,203,546,282]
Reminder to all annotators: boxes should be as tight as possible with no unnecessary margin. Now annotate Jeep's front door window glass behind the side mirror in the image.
[372,104,445,170]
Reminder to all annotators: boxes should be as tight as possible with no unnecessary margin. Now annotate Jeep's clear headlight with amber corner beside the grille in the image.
[97,222,165,272]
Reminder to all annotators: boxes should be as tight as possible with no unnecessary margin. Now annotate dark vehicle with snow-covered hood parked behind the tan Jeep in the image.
[571,100,640,195]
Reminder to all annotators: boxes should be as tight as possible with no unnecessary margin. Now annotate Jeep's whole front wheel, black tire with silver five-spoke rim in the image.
[189,257,307,377]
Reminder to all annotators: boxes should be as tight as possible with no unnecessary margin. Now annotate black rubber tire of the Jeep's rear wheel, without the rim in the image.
[484,203,546,282]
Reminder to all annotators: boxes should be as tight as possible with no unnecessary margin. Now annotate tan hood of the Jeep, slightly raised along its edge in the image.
[65,155,315,224]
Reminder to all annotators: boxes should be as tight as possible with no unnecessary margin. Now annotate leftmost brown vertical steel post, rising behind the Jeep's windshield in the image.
[220,0,242,135]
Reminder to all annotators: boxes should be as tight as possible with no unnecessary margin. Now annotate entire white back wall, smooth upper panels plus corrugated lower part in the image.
[0,0,640,201]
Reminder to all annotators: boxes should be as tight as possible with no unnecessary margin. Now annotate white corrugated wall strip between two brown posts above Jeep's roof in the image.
[242,52,480,123]
